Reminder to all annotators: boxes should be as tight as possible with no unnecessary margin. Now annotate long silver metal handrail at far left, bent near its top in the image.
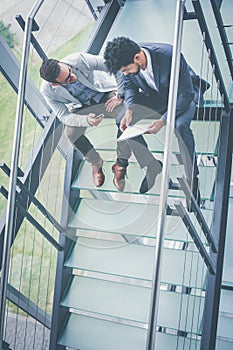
[0,0,44,349]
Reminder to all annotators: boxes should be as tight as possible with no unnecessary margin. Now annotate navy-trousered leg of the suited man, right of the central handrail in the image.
[175,102,200,211]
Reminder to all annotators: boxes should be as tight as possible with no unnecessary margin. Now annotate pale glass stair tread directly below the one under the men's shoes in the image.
[69,199,212,242]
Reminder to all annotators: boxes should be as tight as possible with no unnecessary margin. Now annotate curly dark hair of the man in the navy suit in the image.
[104,36,141,74]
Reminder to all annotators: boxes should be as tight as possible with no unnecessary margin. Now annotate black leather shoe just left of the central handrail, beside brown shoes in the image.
[139,159,163,194]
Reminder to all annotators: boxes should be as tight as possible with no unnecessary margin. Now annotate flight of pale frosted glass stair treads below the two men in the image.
[50,114,219,350]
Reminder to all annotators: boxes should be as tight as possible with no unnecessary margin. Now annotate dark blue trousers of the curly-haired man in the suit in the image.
[116,94,199,181]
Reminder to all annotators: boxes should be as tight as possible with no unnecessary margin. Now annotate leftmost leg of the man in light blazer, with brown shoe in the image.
[65,126,105,187]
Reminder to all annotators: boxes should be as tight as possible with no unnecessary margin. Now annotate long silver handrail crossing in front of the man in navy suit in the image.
[146,0,185,350]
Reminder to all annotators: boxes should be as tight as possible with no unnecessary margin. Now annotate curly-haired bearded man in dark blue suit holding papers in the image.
[104,37,209,209]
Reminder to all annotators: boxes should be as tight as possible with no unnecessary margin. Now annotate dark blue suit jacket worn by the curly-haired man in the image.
[124,43,209,120]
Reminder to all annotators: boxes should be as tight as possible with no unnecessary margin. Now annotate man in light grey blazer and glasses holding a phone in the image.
[40,52,123,187]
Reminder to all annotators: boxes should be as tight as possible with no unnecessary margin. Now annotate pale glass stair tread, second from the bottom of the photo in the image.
[62,276,204,333]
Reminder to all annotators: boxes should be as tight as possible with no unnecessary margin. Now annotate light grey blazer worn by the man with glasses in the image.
[40,52,124,126]
